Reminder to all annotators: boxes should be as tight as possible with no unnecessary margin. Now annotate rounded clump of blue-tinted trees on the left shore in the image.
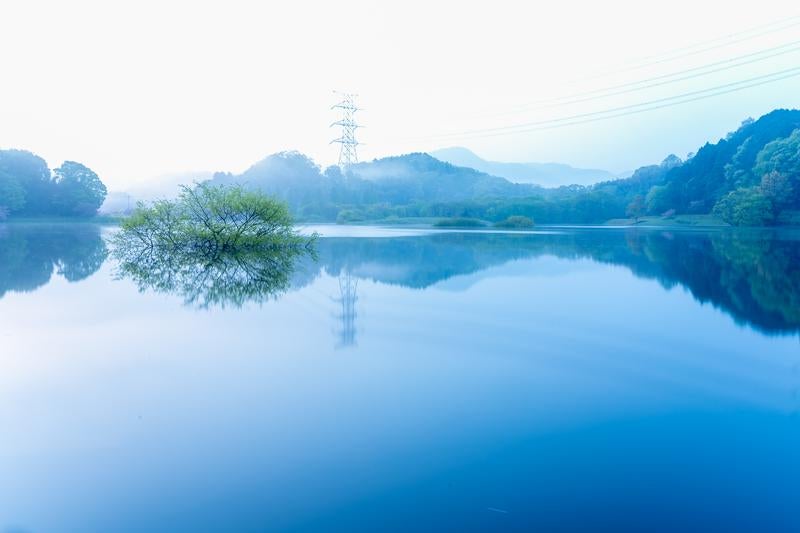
[0,150,106,220]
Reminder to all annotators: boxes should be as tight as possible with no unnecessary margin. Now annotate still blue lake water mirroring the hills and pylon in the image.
[0,225,800,532]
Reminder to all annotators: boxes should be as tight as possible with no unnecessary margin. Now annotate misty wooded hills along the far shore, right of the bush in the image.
[212,110,800,226]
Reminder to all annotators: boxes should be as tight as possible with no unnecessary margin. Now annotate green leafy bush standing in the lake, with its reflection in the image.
[112,183,316,308]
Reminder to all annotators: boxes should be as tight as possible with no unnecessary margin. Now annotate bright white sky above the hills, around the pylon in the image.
[0,0,800,190]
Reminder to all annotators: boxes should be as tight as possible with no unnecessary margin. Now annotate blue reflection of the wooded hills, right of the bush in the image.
[310,230,800,332]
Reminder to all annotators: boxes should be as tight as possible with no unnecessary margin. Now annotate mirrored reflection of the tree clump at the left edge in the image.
[0,224,107,298]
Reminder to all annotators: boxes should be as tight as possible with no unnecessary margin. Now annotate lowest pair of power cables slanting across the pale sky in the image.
[422,67,800,138]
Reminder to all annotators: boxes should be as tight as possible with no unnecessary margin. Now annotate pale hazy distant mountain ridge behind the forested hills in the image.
[429,146,618,187]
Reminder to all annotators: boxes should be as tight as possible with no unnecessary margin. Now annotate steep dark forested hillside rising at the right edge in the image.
[595,110,800,225]
